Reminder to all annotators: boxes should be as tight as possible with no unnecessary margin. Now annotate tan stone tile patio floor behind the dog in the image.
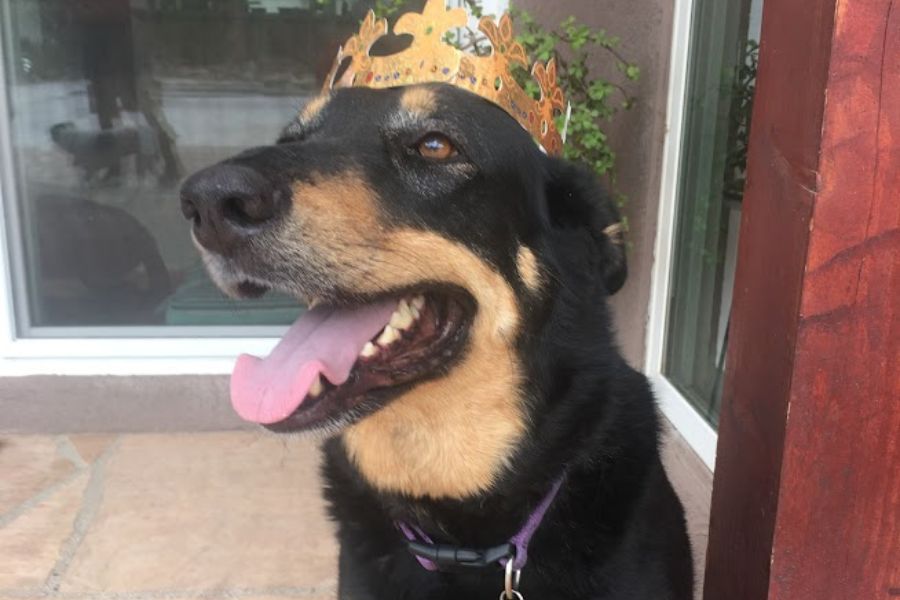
[0,432,709,600]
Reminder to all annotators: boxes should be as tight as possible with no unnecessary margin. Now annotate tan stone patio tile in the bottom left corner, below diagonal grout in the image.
[0,471,88,596]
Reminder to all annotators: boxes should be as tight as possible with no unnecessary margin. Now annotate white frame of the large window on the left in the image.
[0,0,500,377]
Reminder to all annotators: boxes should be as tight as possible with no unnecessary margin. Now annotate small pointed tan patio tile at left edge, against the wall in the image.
[0,435,76,519]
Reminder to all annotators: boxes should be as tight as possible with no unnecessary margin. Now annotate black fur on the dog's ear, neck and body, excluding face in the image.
[324,149,693,600]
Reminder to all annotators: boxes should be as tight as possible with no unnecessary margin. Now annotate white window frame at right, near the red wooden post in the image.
[644,0,718,470]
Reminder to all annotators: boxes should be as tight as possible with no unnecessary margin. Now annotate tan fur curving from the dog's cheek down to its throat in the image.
[343,231,526,498]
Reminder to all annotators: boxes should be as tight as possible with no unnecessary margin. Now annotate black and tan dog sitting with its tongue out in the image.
[182,84,693,600]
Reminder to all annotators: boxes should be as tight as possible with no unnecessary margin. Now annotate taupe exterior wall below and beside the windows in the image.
[0,0,672,432]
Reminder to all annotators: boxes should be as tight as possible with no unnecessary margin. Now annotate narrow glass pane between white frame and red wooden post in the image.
[663,0,762,426]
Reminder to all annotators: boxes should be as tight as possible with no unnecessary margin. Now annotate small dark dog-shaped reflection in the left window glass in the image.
[50,121,160,182]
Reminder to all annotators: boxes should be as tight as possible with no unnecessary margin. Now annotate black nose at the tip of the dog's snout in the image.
[181,163,284,255]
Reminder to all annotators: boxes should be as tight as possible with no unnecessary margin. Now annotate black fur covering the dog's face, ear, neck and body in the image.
[186,86,693,600]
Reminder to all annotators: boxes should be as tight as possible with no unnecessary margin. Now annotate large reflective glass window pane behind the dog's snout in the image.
[0,0,392,335]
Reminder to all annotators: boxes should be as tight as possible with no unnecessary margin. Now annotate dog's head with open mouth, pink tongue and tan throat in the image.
[182,84,625,497]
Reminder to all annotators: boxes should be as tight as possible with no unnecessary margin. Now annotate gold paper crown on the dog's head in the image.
[324,0,566,154]
